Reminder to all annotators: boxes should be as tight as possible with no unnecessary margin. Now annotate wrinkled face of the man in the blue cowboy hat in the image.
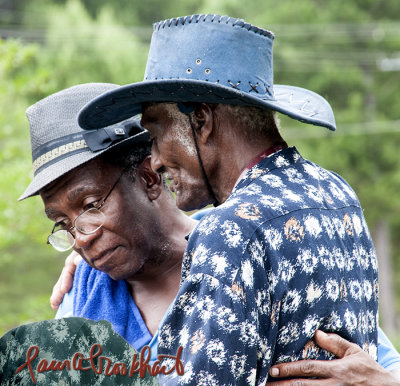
[142,103,212,210]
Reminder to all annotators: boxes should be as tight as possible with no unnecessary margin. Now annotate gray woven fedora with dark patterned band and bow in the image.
[19,83,150,201]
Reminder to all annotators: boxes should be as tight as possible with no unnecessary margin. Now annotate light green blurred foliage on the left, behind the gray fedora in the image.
[0,0,148,335]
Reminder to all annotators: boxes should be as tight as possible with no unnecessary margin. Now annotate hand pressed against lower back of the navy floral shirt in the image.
[270,331,400,386]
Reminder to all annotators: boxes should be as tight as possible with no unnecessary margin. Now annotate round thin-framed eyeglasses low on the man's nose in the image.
[47,170,125,252]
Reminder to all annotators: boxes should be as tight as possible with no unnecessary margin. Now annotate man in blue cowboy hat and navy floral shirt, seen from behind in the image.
[79,15,378,384]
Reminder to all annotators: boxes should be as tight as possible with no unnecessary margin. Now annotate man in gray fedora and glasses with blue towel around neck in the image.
[20,83,195,364]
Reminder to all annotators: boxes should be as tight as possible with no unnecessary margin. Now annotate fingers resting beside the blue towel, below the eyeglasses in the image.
[50,251,82,310]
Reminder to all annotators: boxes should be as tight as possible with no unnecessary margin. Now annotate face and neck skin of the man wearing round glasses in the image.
[40,159,193,334]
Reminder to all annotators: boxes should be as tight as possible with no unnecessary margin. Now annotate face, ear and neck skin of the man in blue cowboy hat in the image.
[142,103,272,210]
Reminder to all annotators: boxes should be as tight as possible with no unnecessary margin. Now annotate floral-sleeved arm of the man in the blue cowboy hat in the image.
[158,219,277,385]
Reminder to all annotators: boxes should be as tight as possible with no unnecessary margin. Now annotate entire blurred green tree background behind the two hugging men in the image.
[0,0,400,348]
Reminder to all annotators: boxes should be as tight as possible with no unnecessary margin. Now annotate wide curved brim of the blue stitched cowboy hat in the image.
[78,79,336,130]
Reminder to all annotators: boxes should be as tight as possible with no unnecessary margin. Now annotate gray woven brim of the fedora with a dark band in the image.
[18,131,150,201]
